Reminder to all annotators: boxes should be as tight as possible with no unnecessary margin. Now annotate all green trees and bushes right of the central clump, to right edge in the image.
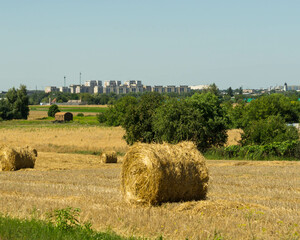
[224,94,300,146]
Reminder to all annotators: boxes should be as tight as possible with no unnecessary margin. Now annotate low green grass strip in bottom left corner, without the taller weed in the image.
[0,215,135,240]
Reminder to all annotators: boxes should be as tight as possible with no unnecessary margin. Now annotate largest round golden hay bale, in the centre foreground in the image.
[121,142,209,205]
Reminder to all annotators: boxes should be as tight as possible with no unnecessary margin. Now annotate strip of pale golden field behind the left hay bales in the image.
[0,125,127,153]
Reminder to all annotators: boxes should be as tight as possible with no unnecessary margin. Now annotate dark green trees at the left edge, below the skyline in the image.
[0,85,29,120]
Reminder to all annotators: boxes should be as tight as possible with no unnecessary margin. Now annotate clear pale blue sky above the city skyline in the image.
[0,0,300,91]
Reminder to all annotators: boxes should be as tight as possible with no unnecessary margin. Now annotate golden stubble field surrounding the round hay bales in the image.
[0,108,300,239]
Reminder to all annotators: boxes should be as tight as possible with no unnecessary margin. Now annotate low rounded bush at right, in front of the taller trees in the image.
[241,116,299,145]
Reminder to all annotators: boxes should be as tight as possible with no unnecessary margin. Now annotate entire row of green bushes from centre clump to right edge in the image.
[98,88,300,158]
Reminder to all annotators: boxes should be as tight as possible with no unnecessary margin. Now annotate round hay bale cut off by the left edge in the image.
[0,147,37,171]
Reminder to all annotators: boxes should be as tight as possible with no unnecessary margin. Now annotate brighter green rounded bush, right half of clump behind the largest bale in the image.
[153,92,227,151]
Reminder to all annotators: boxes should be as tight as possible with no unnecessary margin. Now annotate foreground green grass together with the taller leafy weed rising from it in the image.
[0,207,135,240]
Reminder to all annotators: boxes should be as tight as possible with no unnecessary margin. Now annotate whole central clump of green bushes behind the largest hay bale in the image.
[98,91,227,150]
